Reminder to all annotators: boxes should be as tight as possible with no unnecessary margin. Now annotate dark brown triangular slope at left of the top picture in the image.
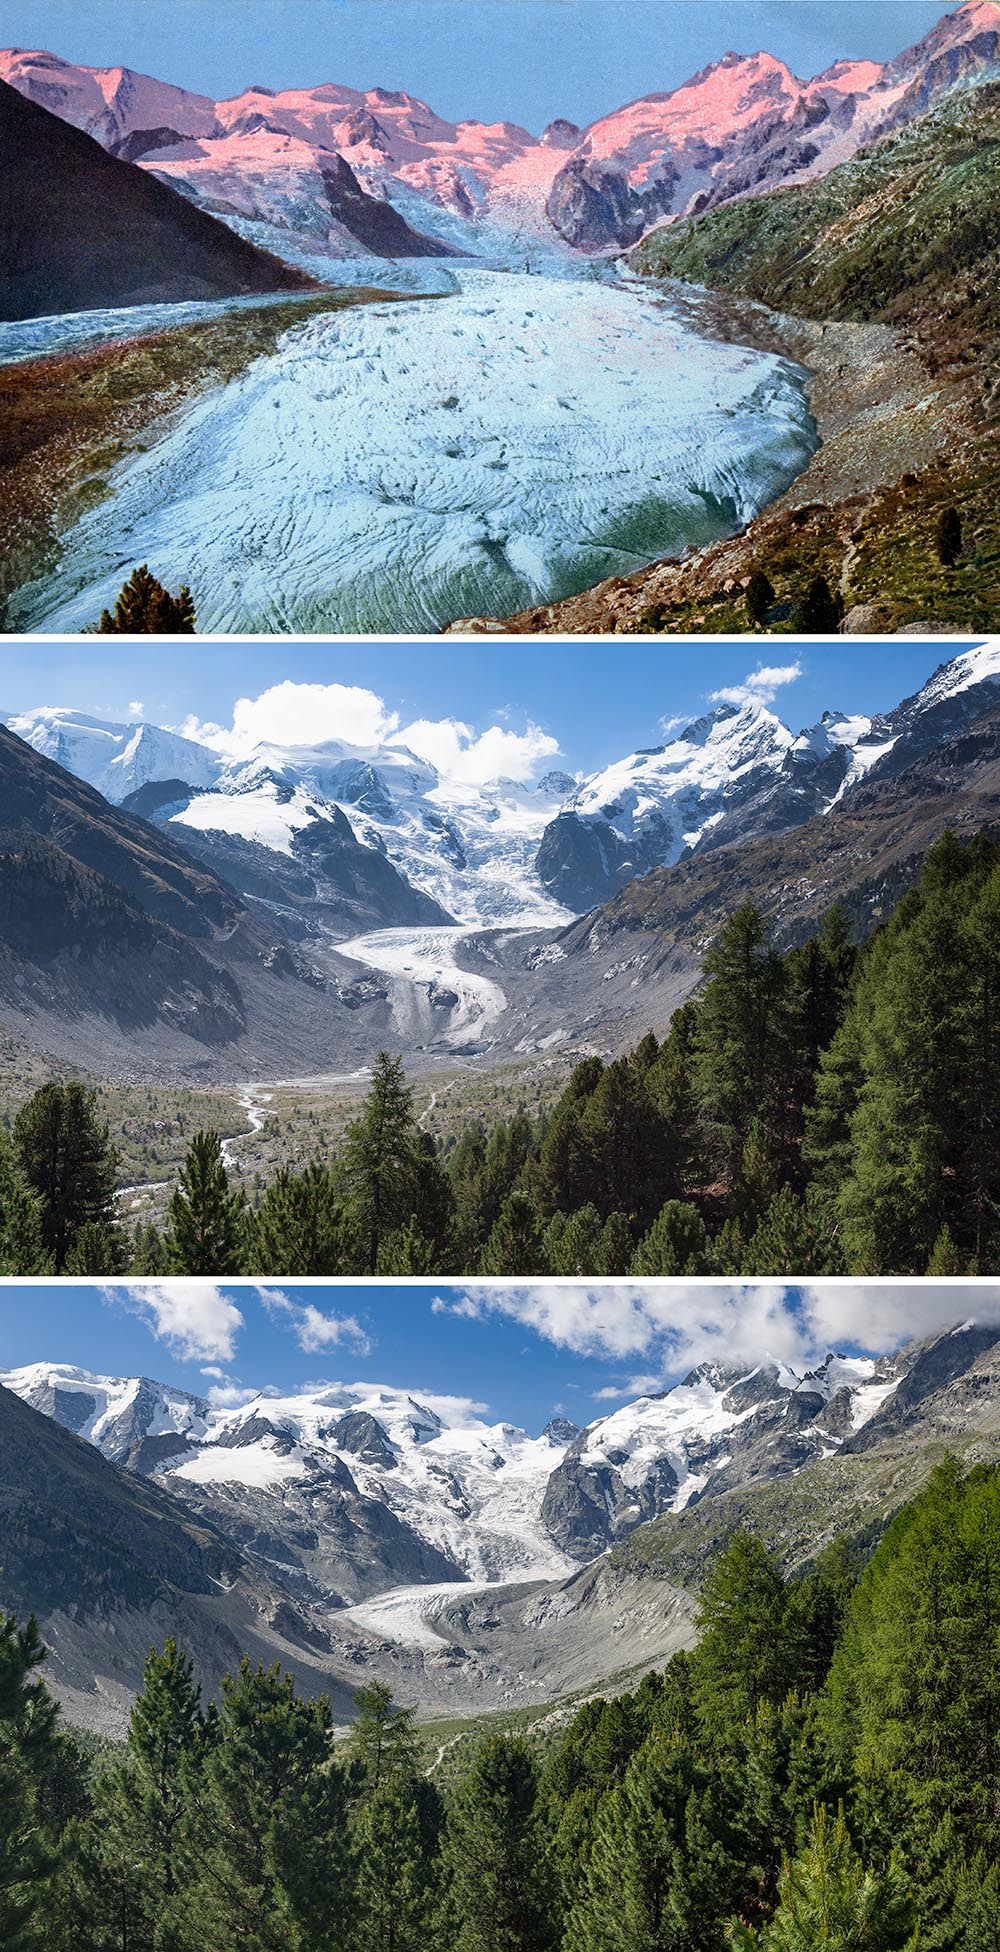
[0,82,313,318]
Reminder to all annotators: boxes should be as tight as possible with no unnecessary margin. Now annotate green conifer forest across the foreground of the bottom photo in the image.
[0,1458,1000,1952]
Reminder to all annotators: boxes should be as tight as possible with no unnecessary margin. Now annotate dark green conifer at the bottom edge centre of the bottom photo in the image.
[441,1735,553,1952]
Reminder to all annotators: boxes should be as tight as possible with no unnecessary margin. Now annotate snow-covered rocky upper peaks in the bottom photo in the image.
[0,1323,996,1600]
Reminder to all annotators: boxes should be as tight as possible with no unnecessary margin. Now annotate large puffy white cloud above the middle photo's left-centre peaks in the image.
[178,677,398,759]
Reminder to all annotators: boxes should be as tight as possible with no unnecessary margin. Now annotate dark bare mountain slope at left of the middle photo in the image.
[0,728,419,1076]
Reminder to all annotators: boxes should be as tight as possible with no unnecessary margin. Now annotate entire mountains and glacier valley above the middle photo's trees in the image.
[0,644,1000,1081]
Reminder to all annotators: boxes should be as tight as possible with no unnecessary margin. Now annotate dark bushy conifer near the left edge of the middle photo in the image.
[14,1081,125,1275]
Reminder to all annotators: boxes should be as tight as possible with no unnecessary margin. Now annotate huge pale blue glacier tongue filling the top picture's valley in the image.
[8,260,816,632]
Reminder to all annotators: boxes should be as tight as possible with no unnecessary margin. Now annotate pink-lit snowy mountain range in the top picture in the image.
[0,0,1000,256]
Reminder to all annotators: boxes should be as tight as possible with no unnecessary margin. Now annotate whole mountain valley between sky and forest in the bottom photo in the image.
[0,1322,1000,1726]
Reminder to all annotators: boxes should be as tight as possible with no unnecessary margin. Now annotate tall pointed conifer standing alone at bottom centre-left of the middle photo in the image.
[344,1050,418,1275]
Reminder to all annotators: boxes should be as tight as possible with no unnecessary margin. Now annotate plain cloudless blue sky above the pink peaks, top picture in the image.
[0,0,955,131]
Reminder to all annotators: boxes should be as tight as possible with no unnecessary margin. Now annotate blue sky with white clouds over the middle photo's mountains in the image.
[0,638,973,775]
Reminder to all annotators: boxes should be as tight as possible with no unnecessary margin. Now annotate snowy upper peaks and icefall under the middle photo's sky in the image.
[6,642,1000,937]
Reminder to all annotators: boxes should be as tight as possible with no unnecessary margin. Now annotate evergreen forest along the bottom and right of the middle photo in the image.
[0,834,1000,1277]
